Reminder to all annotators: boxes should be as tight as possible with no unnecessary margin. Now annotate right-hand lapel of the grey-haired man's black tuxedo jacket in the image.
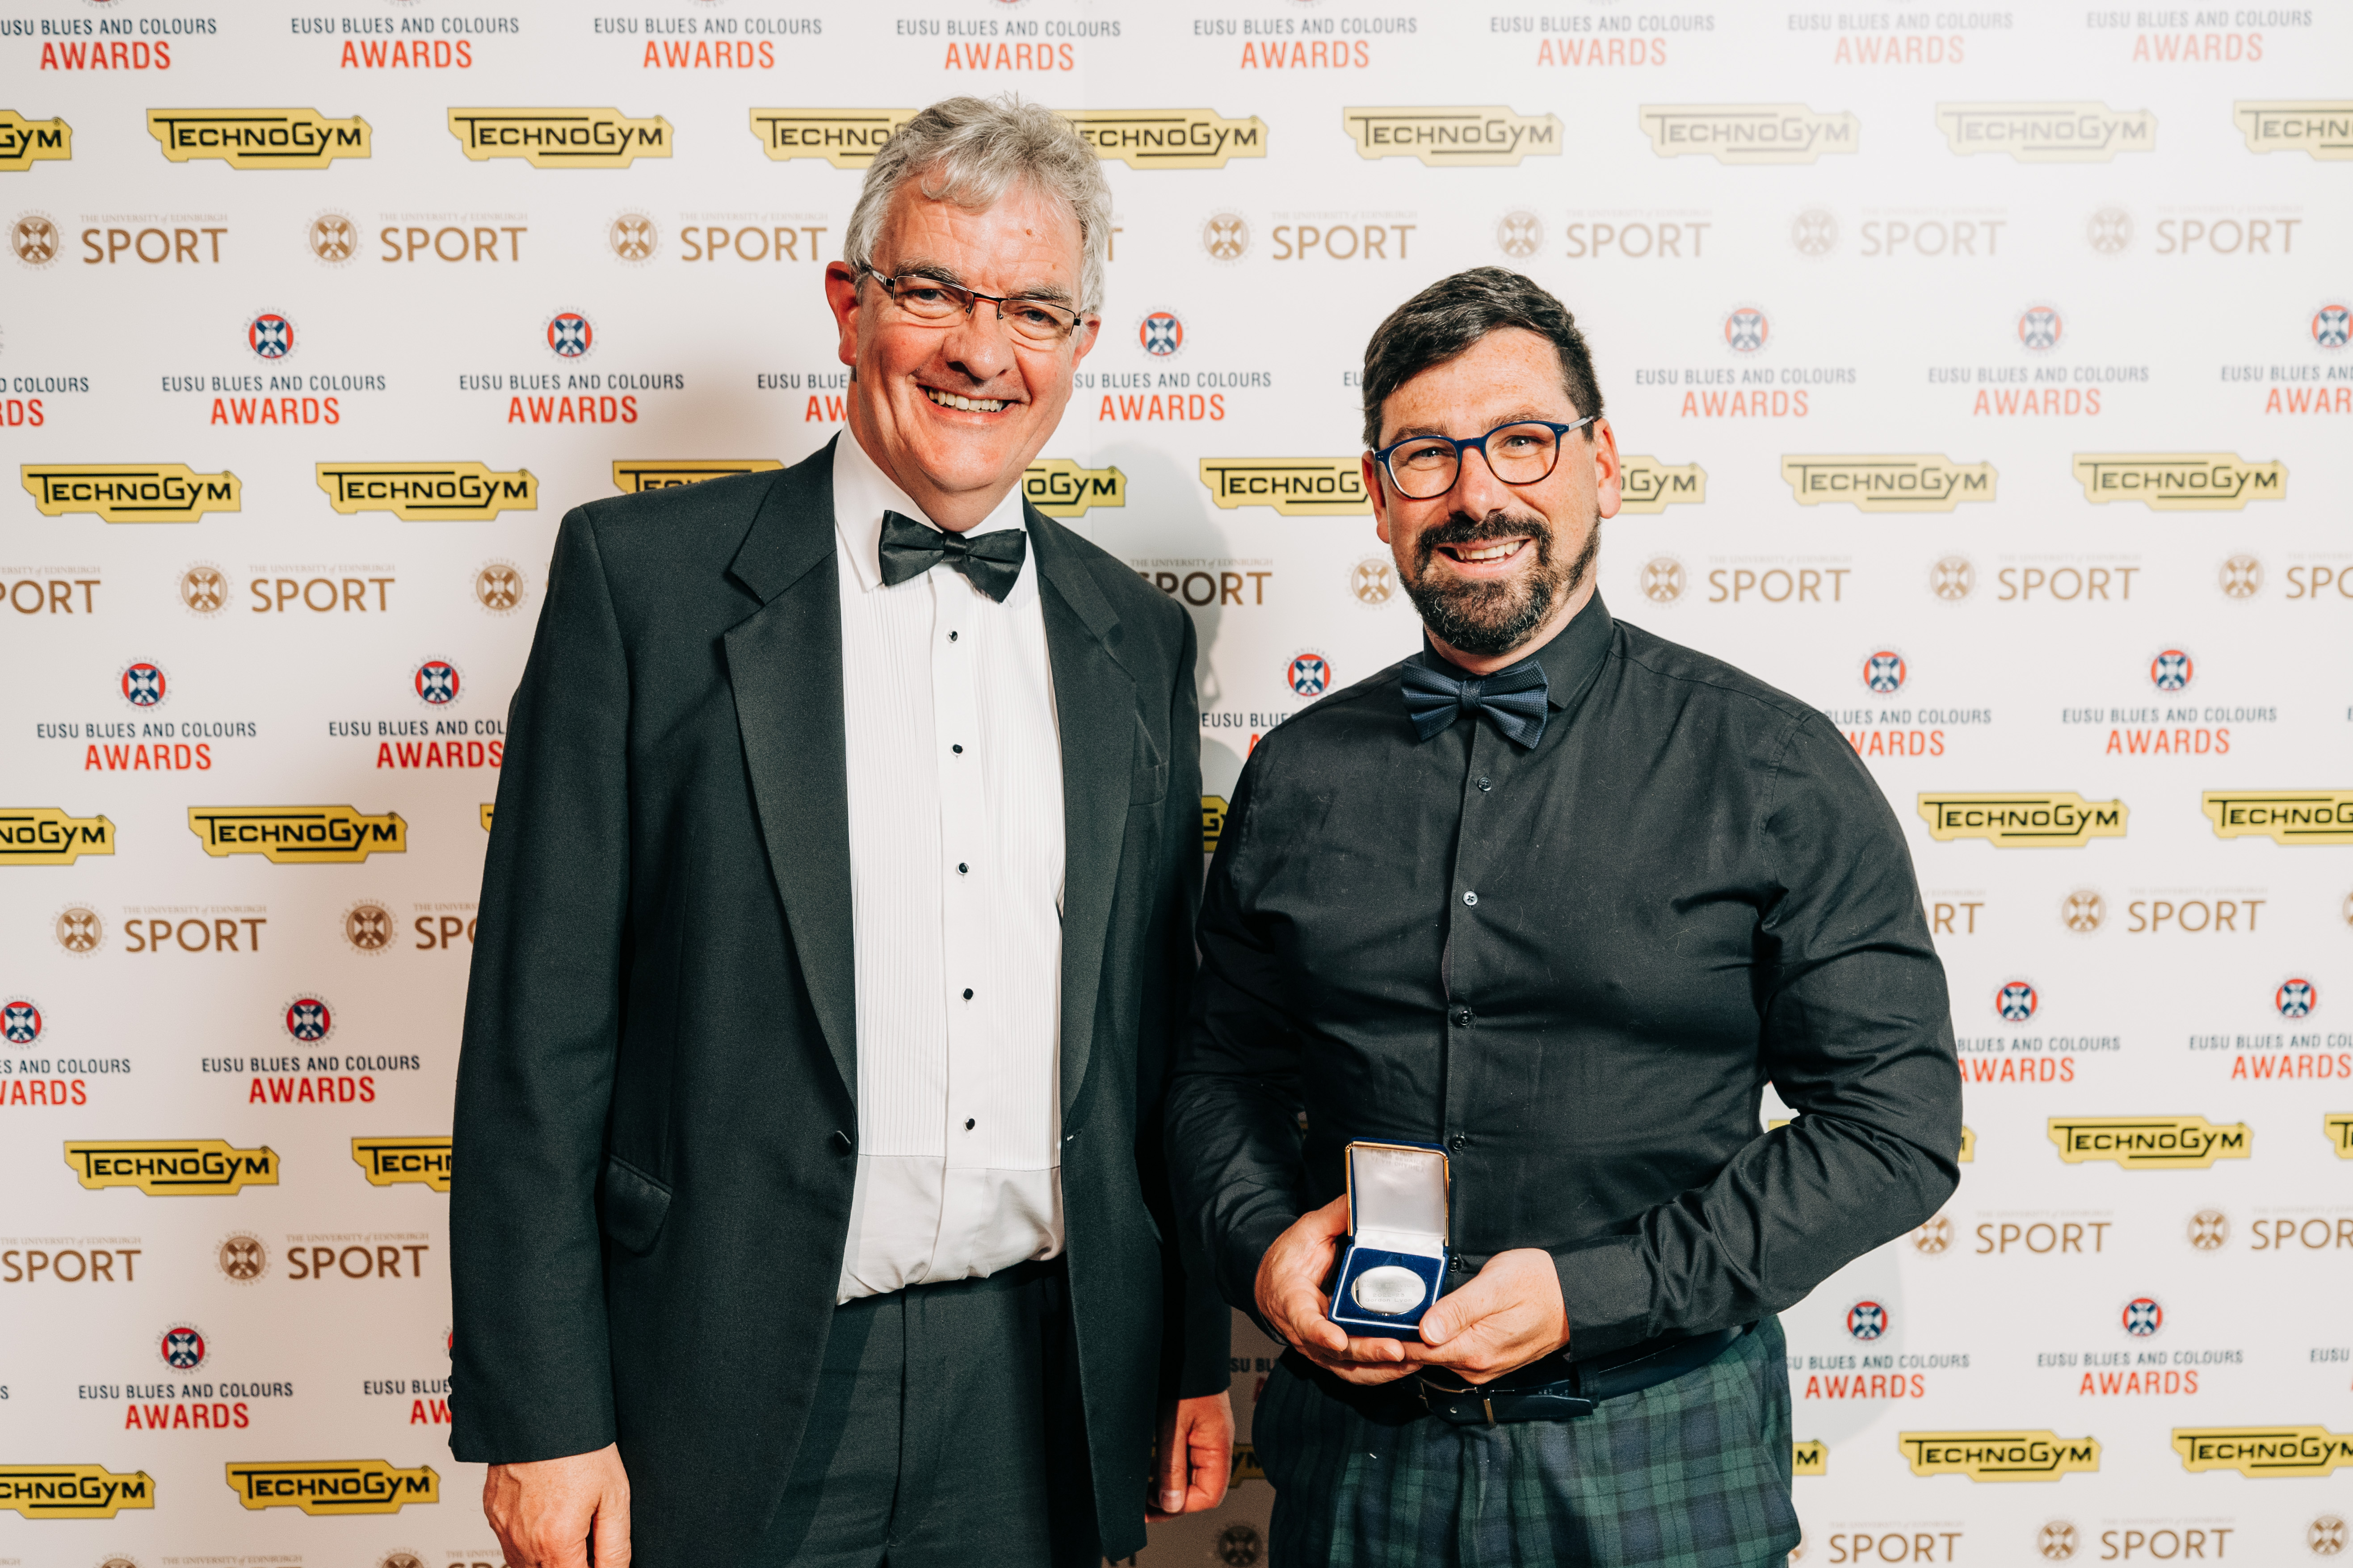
[1026,509,1136,1116]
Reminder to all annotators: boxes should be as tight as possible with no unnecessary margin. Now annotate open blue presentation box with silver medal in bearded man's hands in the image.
[1332,1142,1450,1340]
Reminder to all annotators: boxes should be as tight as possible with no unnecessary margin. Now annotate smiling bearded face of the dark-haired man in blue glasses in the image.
[1365,327,1619,673]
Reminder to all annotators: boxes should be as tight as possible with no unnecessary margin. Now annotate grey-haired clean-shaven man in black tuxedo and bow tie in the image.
[450,99,1233,1568]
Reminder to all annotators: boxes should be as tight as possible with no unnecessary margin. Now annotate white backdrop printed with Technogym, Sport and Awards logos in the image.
[0,0,2353,1568]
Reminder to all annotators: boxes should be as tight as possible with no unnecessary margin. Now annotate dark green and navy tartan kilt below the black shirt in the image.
[1252,1316,1798,1568]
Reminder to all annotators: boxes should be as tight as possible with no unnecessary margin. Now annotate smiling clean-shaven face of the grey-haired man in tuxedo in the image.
[826,179,1101,530]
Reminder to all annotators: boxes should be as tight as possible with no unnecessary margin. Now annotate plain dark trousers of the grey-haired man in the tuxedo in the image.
[751,1260,1101,1568]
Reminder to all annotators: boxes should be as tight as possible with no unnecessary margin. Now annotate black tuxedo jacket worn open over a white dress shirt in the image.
[450,447,1228,1568]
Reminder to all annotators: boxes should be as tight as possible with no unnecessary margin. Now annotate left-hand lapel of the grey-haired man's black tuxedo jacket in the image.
[725,445,859,1100]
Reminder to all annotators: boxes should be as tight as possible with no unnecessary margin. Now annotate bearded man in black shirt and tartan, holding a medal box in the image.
[1169,269,1960,1568]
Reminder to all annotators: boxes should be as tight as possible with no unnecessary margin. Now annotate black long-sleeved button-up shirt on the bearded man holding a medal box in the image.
[1169,596,1960,1356]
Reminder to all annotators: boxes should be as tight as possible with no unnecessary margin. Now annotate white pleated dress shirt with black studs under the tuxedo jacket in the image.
[833,431,1063,1302]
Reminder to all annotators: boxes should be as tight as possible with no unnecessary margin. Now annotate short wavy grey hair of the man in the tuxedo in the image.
[842,94,1111,315]
